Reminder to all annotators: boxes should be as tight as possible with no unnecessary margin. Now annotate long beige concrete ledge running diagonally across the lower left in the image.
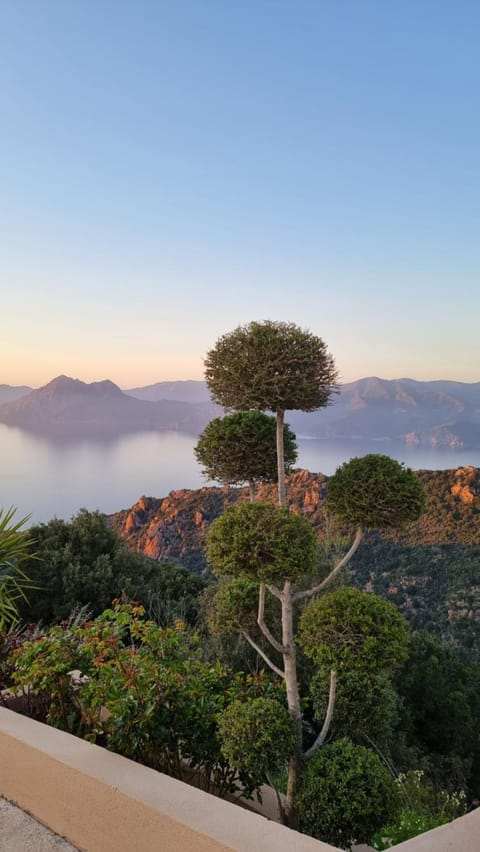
[0,708,338,852]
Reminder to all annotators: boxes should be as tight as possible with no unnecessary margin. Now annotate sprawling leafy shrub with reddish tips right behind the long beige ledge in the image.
[11,601,282,796]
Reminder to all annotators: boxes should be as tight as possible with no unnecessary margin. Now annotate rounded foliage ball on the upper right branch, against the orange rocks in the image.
[326,453,425,529]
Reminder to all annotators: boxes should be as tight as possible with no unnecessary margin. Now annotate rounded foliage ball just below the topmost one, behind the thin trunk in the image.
[194,411,297,501]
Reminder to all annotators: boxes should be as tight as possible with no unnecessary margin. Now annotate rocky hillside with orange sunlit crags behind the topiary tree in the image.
[111,467,480,655]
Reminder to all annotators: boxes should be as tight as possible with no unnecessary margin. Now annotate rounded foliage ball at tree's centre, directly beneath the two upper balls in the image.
[206,502,318,583]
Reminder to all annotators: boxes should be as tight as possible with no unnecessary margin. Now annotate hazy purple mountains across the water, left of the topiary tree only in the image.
[0,376,216,435]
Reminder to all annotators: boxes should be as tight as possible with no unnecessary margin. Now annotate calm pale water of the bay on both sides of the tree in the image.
[0,424,480,522]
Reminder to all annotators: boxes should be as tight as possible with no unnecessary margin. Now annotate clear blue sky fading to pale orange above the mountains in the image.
[0,0,480,387]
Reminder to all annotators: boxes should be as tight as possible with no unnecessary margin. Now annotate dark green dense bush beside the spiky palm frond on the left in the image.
[19,510,205,625]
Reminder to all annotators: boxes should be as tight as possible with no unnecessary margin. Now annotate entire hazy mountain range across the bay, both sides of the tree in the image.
[0,376,480,449]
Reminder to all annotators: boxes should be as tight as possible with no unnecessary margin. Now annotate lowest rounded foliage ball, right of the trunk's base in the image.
[295,738,400,849]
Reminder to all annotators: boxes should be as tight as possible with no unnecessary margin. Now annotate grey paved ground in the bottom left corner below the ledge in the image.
[0,798,77,852]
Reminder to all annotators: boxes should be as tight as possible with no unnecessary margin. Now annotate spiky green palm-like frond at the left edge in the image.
[0,507,33,630]
